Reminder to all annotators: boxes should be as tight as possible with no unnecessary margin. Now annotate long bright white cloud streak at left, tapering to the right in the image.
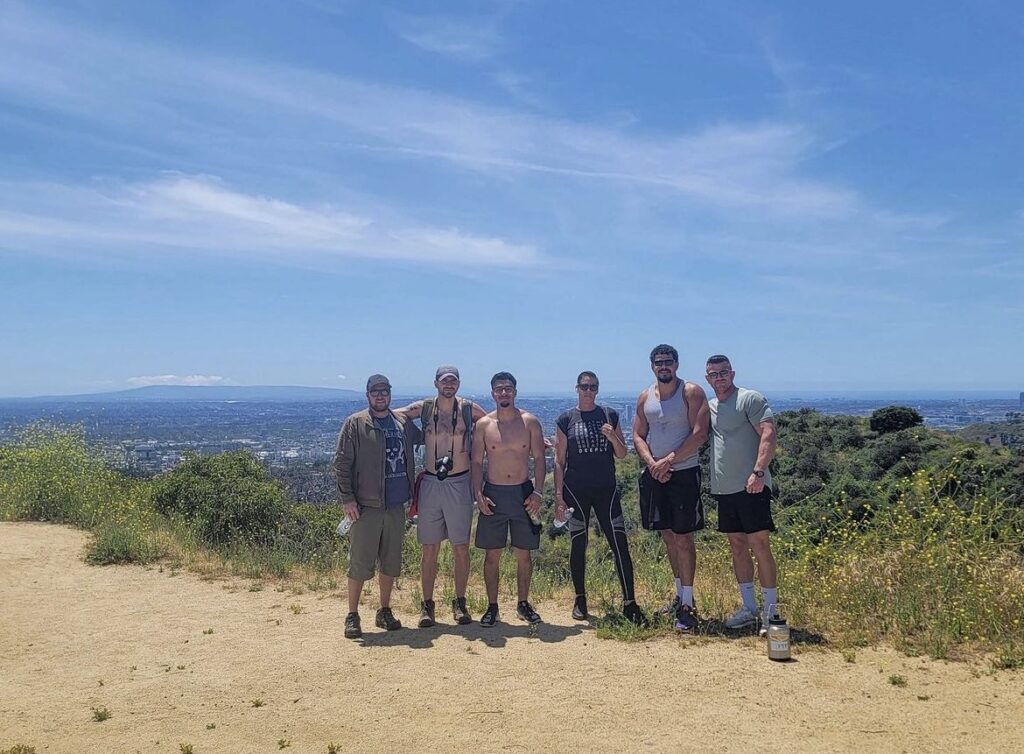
[0,174,545,267]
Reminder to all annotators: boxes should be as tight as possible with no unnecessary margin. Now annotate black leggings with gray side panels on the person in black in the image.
[562,485,636,602]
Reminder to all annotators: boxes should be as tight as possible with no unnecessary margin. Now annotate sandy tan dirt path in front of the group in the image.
[0,523,1024,754]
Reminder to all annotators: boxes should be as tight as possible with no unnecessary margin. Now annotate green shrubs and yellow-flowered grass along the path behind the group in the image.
[0,411,1024,667]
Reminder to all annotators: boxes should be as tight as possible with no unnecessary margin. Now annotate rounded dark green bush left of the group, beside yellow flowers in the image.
[154,451,288,545]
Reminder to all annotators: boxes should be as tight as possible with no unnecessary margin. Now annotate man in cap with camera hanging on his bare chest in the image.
[395,364,486,628]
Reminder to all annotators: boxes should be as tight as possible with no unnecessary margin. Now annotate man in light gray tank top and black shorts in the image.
[633,343,709,633]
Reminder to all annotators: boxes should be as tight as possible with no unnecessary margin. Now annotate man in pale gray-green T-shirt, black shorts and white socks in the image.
[707,354,778,633]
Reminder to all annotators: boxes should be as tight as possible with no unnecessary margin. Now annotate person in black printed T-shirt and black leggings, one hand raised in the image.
[555,372,647,625]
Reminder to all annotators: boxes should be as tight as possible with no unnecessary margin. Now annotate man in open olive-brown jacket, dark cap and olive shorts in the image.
[334,374,418,639]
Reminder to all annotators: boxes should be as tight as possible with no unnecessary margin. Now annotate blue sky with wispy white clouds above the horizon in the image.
[0,0,1024,396]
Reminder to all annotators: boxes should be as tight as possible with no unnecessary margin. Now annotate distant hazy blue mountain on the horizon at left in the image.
[4,385,362,404]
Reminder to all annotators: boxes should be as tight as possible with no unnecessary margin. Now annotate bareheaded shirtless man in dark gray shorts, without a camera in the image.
[472,372,546,626]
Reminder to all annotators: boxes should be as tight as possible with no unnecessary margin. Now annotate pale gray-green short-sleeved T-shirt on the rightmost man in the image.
[708,387,774,495]
